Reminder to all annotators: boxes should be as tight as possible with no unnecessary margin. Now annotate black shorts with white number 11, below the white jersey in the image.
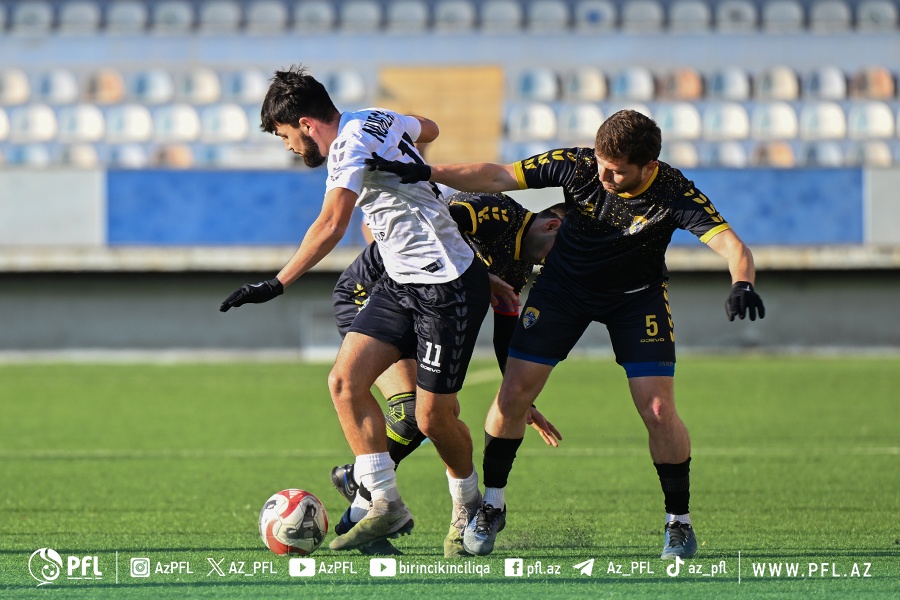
[348,259,491,394]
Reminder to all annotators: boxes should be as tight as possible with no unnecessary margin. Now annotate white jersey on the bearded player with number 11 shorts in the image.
[325,108,474,283]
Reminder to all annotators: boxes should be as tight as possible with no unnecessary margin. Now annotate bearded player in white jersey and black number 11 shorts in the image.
[219,66,491,550]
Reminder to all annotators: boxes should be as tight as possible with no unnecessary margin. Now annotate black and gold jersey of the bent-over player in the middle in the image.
[447,192,534,294]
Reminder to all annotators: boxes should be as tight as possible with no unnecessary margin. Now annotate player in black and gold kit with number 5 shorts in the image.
[367,110,765,559]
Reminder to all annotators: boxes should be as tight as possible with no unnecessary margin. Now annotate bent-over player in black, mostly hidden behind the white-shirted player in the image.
[331,192,565,558]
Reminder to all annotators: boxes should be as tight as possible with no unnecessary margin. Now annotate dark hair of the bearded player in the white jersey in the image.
[259,65,340,133]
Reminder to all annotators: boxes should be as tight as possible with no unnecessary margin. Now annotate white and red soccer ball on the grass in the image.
[259,489,328,556]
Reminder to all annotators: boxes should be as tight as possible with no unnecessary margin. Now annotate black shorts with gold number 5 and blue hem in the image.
[509,276,675,377]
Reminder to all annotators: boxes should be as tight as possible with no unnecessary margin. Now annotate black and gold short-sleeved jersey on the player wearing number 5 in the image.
[514,148,730,293]
